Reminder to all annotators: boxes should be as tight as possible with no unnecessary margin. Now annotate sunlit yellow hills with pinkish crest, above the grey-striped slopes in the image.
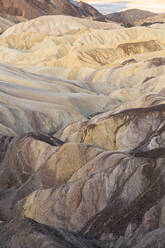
[0,16,165,73]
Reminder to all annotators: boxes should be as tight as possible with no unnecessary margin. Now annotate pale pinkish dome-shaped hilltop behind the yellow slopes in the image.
[3,15,121,37]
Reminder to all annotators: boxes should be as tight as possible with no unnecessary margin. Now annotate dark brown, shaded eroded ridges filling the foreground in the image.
[0,105,165,248]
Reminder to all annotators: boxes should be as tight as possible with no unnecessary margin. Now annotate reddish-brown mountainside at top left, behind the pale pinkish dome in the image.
[0,0,101,19]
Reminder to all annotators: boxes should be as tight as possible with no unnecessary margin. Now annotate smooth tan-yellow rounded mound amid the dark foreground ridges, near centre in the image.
[43,143,103,187]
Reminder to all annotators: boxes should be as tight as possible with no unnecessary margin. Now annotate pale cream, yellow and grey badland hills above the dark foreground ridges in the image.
[0,16,165,138]
